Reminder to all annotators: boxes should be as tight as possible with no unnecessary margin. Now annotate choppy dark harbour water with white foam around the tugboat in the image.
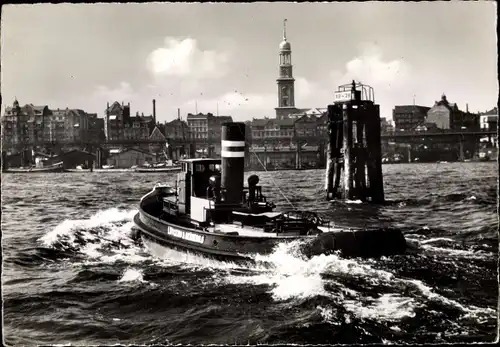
[2,163,498,345]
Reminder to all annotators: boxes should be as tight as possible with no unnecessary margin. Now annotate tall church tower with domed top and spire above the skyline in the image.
[276,19,295,119]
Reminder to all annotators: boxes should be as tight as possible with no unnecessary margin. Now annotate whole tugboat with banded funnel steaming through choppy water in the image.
[134,122,406,260]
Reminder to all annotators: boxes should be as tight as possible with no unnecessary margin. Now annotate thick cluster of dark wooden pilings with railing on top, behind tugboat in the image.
[325,82,384,203]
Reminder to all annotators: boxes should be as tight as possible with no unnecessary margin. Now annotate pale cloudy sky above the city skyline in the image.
[1,1,498,122]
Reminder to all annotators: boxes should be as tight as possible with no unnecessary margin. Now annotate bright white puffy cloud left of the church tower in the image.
[147,37,229,78]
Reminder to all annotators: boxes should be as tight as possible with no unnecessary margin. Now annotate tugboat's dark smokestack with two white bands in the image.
[221,123,245,204]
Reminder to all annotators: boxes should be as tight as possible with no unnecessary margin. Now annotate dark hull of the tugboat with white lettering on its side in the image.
[134,187,407,260]
